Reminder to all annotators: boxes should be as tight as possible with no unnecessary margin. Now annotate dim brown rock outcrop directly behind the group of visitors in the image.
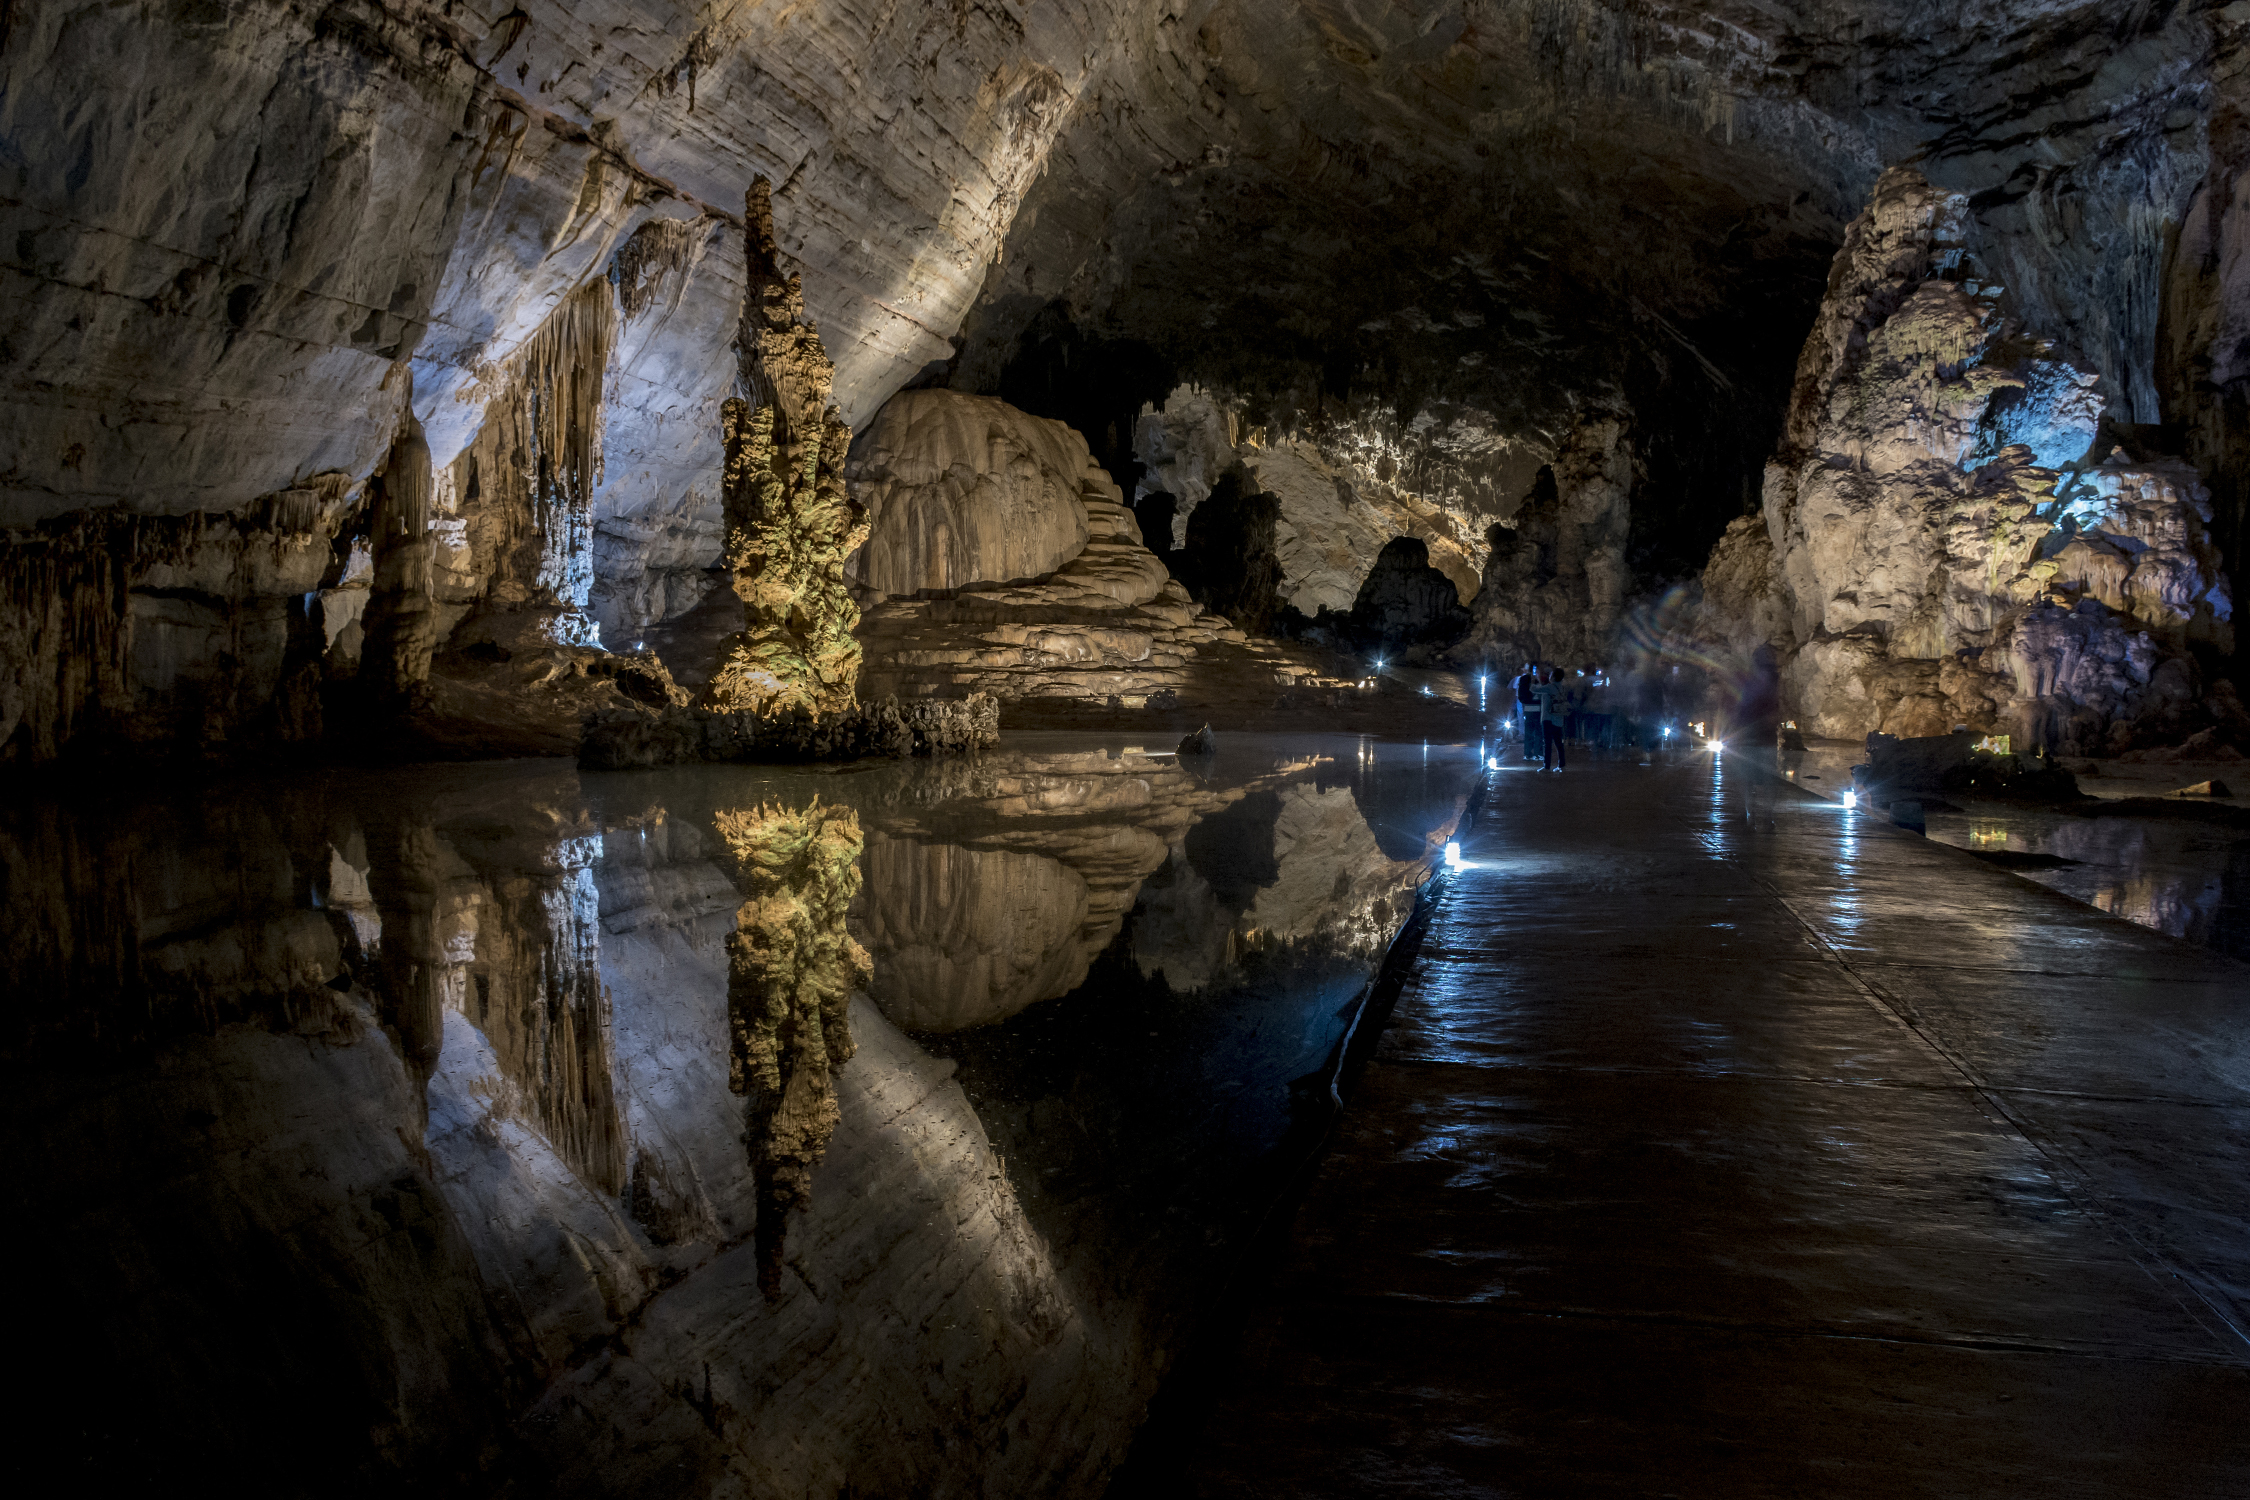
[1451,416,1638,668]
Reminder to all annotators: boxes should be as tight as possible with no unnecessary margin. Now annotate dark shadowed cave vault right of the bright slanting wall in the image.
[956,0,2210,458]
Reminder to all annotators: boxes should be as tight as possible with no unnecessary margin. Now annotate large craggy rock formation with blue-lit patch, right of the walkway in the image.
[1703,169,2234,753]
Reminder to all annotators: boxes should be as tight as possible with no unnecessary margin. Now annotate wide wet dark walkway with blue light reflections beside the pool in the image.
[1188,758,2250,1496]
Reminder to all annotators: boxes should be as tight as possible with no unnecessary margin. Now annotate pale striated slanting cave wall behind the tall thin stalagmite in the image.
[0,0,1161,760]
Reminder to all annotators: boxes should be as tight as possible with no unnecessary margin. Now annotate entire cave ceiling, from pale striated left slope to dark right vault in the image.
[0,0,2243,524]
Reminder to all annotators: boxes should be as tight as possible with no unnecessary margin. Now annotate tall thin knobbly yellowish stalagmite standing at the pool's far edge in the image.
[704,178,866,717]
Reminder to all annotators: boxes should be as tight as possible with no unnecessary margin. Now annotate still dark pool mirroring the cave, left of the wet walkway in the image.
[0,735,1476,1493]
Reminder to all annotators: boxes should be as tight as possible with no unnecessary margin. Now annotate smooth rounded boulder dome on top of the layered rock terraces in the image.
[844,391,1091,596]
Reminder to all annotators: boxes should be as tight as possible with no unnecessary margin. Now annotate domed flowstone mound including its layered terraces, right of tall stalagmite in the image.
[846,391,1242,704]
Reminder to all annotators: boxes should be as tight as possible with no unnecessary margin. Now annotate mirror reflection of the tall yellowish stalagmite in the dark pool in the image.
[718,801,873,1298]
